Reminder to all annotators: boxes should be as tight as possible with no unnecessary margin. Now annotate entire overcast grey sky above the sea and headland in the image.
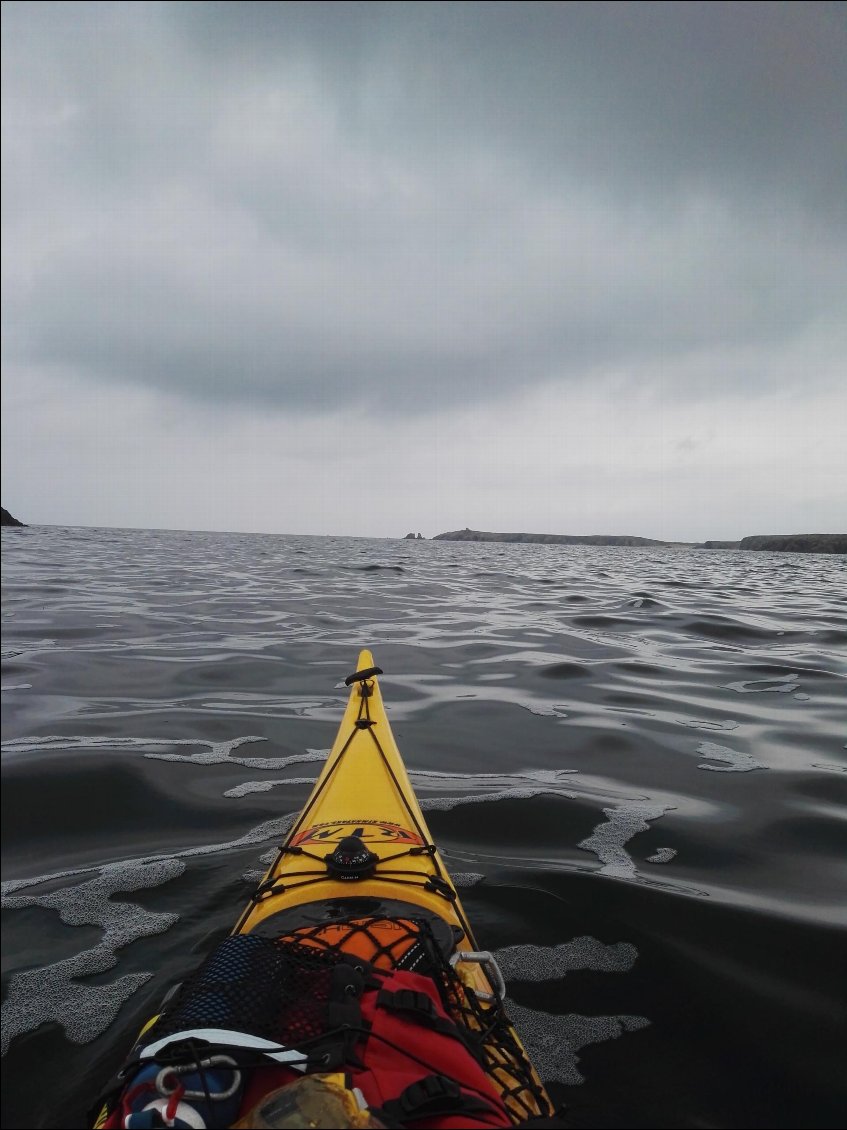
[2,0,847,540]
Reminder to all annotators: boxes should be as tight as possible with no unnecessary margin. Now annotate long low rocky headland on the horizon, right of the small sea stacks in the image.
[433,528,847,554]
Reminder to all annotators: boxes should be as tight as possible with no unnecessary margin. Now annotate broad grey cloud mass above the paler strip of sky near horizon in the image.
[3,2,847,411]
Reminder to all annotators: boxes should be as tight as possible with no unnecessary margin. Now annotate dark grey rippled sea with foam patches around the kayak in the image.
[2,527,847,1128]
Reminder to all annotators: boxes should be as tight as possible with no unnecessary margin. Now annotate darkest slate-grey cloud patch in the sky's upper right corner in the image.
[182,0,847,218]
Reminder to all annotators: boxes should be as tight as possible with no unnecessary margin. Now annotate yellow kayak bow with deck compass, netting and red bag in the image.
[95,651,557,1130]
